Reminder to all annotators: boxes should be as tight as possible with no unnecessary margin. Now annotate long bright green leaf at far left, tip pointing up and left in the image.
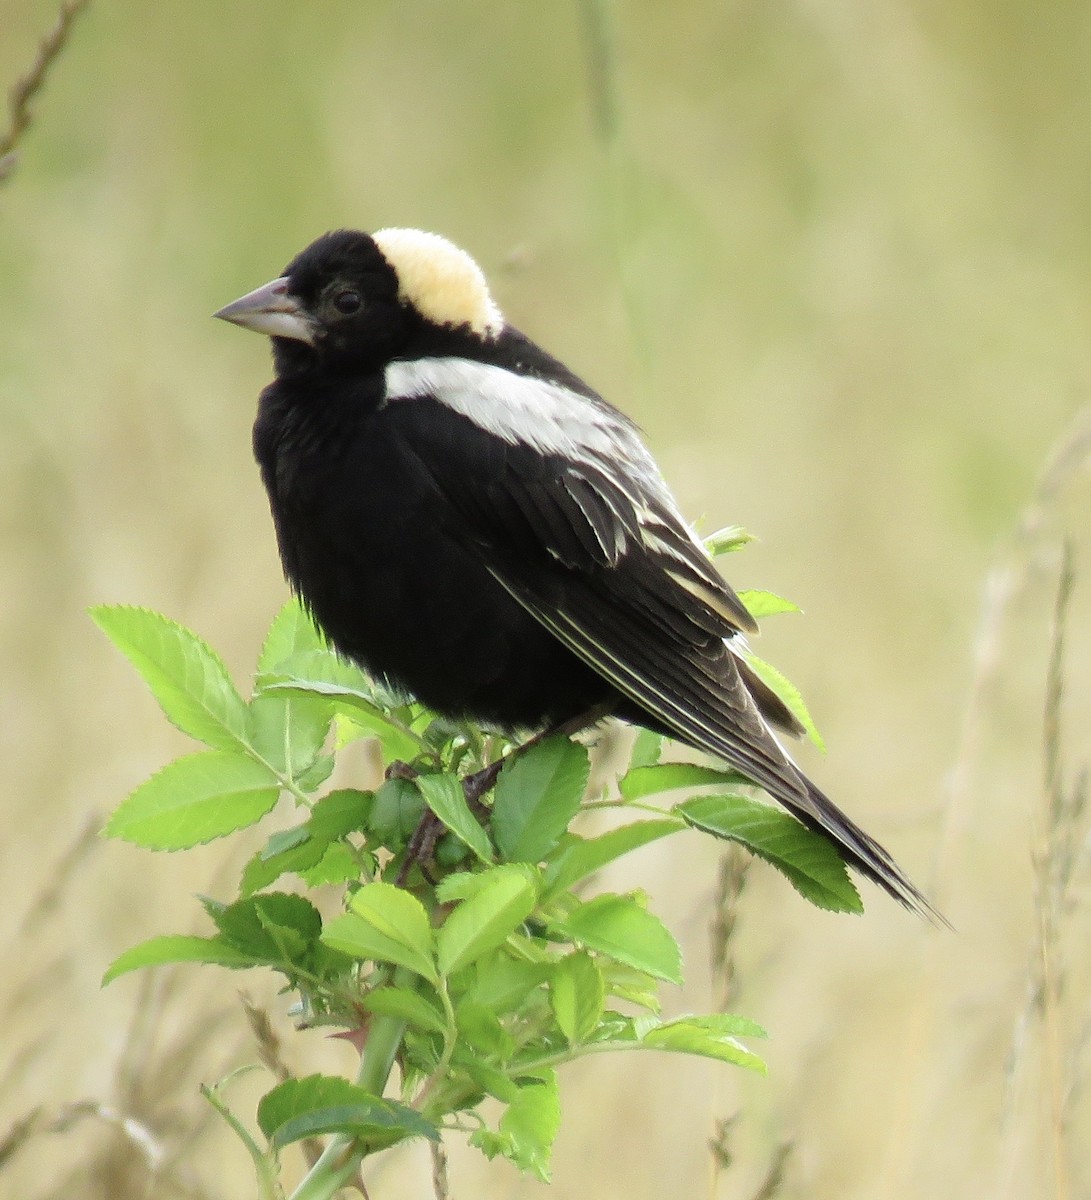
[91,605,246,750]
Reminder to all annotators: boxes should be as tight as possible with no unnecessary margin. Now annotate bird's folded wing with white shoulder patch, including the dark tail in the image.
[379,359,929,911]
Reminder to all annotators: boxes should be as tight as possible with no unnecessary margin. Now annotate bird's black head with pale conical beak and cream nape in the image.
[215,229,504,368]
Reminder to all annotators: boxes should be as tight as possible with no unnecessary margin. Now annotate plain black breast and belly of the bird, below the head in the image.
[254,376,611,728]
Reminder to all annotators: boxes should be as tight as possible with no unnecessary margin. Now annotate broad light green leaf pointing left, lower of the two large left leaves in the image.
[103,750,281,850]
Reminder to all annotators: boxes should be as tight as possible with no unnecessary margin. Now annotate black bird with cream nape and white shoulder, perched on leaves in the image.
[215,228,936,917]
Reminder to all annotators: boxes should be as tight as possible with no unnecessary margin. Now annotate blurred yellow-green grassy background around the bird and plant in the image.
[0,0,1091,1200]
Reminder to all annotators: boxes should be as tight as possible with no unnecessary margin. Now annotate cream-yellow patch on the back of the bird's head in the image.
[372,229,504,337]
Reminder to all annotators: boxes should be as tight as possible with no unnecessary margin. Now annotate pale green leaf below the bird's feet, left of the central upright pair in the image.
[322,881,436,980]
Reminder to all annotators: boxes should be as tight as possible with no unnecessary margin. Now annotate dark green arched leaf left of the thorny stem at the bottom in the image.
[258,1075,439,1147]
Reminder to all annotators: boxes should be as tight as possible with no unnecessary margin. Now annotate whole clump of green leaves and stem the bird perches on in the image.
[94,595,859,1200]
